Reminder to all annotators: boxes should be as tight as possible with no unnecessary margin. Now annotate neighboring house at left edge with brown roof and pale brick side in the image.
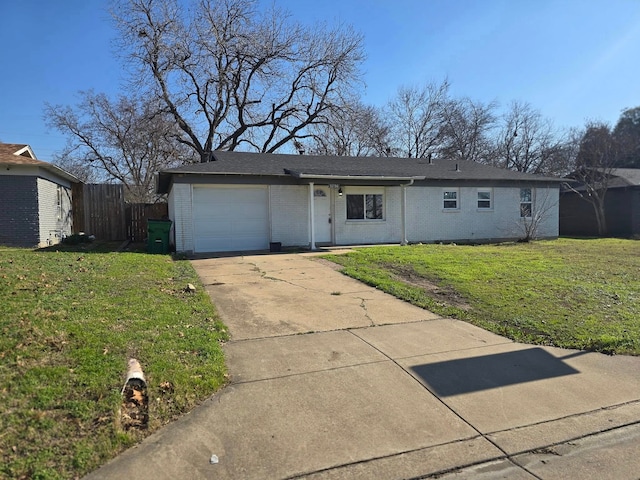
[0,143,80,247]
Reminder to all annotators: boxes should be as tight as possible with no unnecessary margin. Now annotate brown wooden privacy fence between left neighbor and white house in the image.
[72,184,168,242]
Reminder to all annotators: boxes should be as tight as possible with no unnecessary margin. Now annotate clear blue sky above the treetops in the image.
[0,0,640,161]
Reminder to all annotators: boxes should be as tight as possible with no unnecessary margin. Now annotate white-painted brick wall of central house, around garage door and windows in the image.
[169,183,558,252]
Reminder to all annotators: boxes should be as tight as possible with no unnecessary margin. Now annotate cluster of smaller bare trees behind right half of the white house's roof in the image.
[387,85,571,175]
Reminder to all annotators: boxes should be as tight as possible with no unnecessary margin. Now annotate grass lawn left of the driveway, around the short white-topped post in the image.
[0,247,227,479]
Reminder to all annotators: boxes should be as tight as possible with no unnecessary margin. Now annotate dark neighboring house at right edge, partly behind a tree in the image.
[560,168,640,237]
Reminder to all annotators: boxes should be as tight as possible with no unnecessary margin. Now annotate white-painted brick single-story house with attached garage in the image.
[158,151,561,253]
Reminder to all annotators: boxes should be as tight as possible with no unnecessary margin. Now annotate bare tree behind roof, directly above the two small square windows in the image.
[440,97,496,163]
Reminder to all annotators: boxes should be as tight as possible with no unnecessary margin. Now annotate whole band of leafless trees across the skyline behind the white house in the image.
[45,0,640,201]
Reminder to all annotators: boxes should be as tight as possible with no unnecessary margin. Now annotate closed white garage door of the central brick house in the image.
[193,185,269,252]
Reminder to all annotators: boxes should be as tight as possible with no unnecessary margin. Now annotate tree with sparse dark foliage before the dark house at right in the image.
[569,120,622,235]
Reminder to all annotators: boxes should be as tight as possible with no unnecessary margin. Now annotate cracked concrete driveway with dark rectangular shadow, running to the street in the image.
[87,254,640,480]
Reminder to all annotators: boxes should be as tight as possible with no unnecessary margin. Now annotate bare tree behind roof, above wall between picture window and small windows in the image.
[387,80,449,158]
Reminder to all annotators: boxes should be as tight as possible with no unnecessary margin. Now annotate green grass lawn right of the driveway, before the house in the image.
[325,239,640,355]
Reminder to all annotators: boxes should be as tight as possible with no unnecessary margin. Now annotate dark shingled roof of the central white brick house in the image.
[158,151,562,193]
